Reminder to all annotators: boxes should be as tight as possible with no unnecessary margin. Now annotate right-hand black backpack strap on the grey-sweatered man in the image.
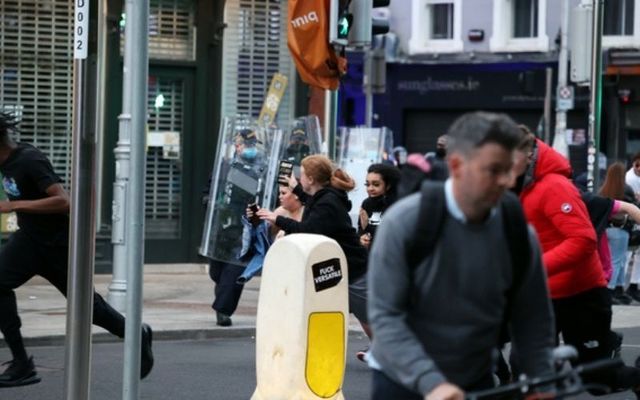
[500,192,531,333]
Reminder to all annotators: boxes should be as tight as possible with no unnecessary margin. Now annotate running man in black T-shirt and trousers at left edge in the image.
[0,112,153,387]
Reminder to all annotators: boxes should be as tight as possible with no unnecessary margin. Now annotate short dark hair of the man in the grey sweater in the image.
[447,111,522,155]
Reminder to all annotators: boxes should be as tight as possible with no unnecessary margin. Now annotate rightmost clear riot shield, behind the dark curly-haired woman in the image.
[338,127,393,226]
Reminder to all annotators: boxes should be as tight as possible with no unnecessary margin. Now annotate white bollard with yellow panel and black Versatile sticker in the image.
[251,234,349,400]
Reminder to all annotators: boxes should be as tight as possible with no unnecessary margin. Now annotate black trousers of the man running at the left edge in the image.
[0,231,125,354]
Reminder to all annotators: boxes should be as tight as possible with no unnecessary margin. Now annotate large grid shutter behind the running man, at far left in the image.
[0,0,73,184]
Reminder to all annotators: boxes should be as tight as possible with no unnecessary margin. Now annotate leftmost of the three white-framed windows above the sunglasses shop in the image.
[409,0,463,54]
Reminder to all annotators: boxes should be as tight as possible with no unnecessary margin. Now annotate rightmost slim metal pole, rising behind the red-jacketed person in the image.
[587,0,603,191]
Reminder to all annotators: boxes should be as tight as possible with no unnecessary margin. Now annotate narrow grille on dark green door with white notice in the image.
[145,76,184,239]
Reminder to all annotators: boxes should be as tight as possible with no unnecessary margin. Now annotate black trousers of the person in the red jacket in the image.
[553,287,640,390]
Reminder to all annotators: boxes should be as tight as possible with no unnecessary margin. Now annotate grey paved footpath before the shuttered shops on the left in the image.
[10,264,364,347]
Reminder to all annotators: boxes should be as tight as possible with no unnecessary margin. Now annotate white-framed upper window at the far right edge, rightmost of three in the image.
[602,0,640,47]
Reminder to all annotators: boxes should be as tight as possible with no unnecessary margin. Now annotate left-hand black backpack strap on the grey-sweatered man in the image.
[407,181,447,269]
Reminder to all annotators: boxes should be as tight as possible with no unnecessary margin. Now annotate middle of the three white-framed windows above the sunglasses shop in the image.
[489,0,549,52]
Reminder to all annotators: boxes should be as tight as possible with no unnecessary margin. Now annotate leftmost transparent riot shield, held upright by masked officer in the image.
[200,116,275,265]
